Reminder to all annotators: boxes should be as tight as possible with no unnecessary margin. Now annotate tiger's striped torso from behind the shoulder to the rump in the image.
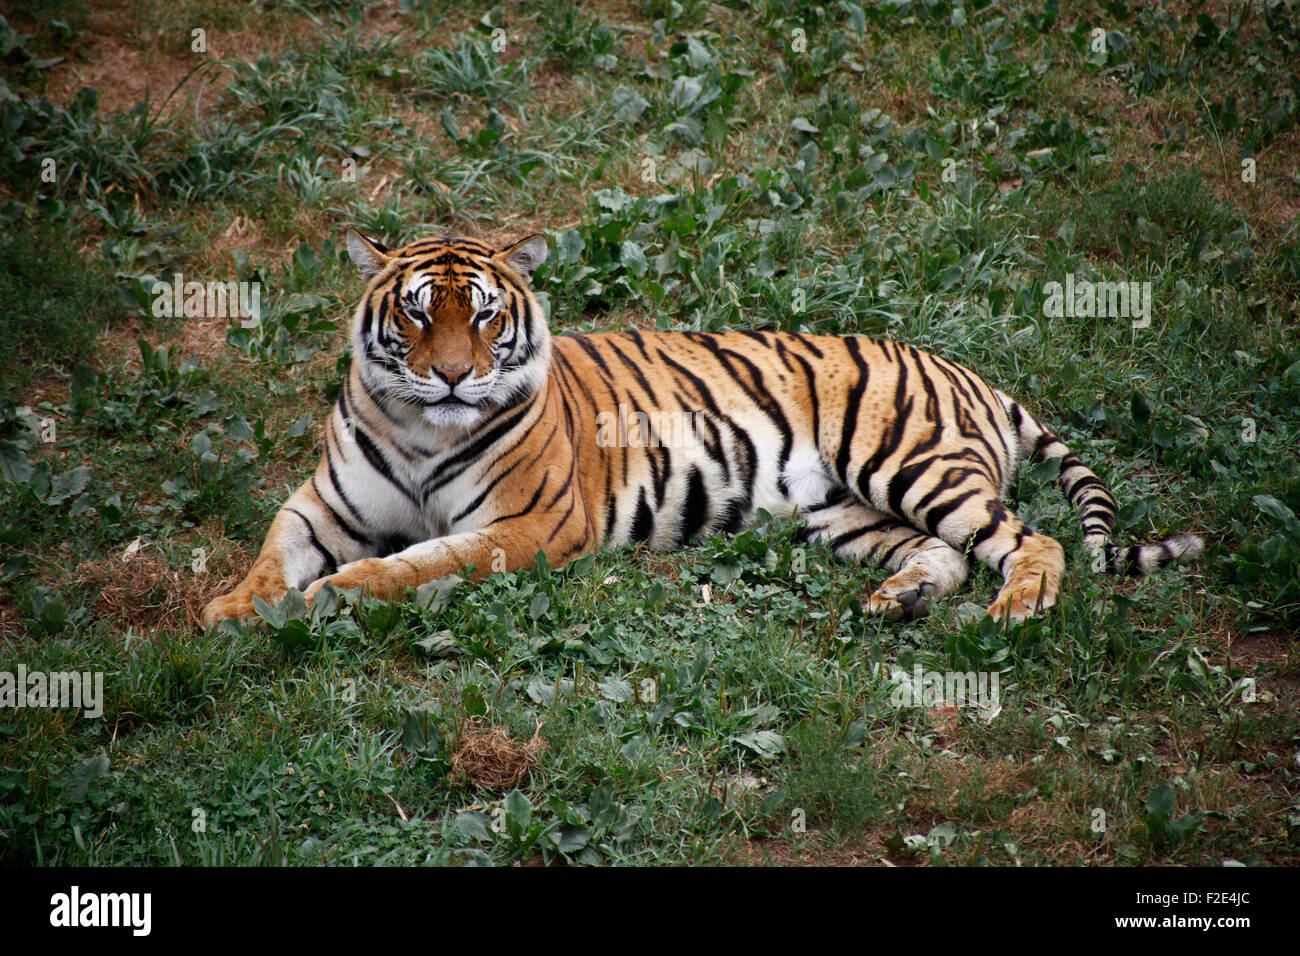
[553,332,1003,550]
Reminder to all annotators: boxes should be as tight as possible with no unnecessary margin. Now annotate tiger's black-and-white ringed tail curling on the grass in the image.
[998,393,1205,575]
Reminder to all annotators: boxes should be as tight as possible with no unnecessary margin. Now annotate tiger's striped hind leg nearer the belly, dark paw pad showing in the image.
[803,498,969,620]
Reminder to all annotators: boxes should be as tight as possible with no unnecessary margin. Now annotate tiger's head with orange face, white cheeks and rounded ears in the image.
[347,230,551,429]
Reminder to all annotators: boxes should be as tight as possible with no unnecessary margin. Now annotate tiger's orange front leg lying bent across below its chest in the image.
[307,510,598,602]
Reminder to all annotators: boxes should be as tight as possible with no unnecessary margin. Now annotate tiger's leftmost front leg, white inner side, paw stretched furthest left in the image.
[203,480,374,627]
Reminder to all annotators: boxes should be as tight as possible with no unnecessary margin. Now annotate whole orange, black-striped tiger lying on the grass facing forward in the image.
[203,230,1204,627]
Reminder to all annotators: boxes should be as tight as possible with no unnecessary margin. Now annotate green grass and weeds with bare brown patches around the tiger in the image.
[0,0,1300,865]
